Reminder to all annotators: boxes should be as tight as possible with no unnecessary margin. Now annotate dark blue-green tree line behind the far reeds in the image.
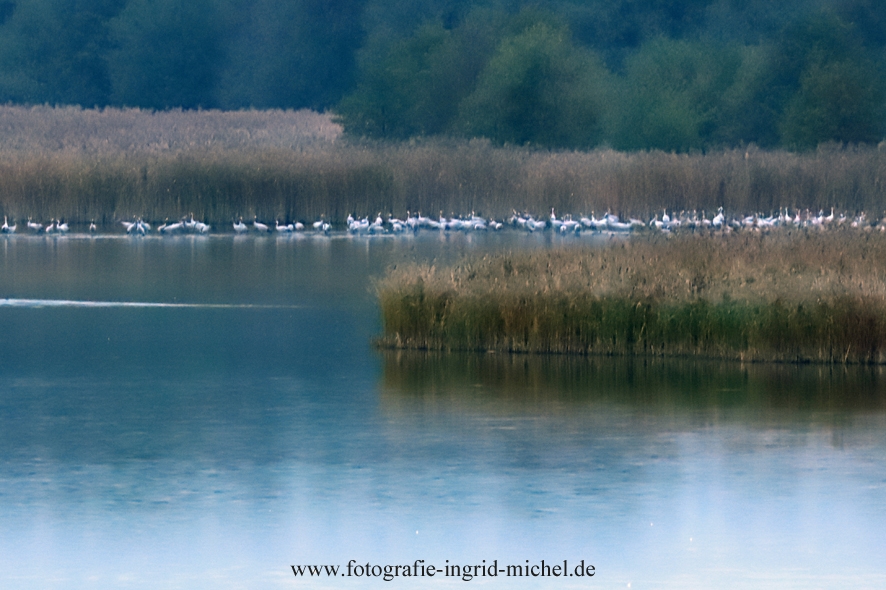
[0,0,886,151]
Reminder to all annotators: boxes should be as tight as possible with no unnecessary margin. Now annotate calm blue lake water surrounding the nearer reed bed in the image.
[0,235,886,589]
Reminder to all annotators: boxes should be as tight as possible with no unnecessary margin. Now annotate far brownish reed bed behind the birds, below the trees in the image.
[0,106,886,226]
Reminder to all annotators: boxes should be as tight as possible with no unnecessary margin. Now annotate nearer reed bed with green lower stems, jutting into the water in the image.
[377,230,886,363]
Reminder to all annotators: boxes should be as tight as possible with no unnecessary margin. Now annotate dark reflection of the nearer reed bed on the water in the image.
[380,351,886,416]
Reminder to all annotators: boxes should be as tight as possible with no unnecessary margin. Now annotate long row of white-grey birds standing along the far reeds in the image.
[0,207,886,236]
